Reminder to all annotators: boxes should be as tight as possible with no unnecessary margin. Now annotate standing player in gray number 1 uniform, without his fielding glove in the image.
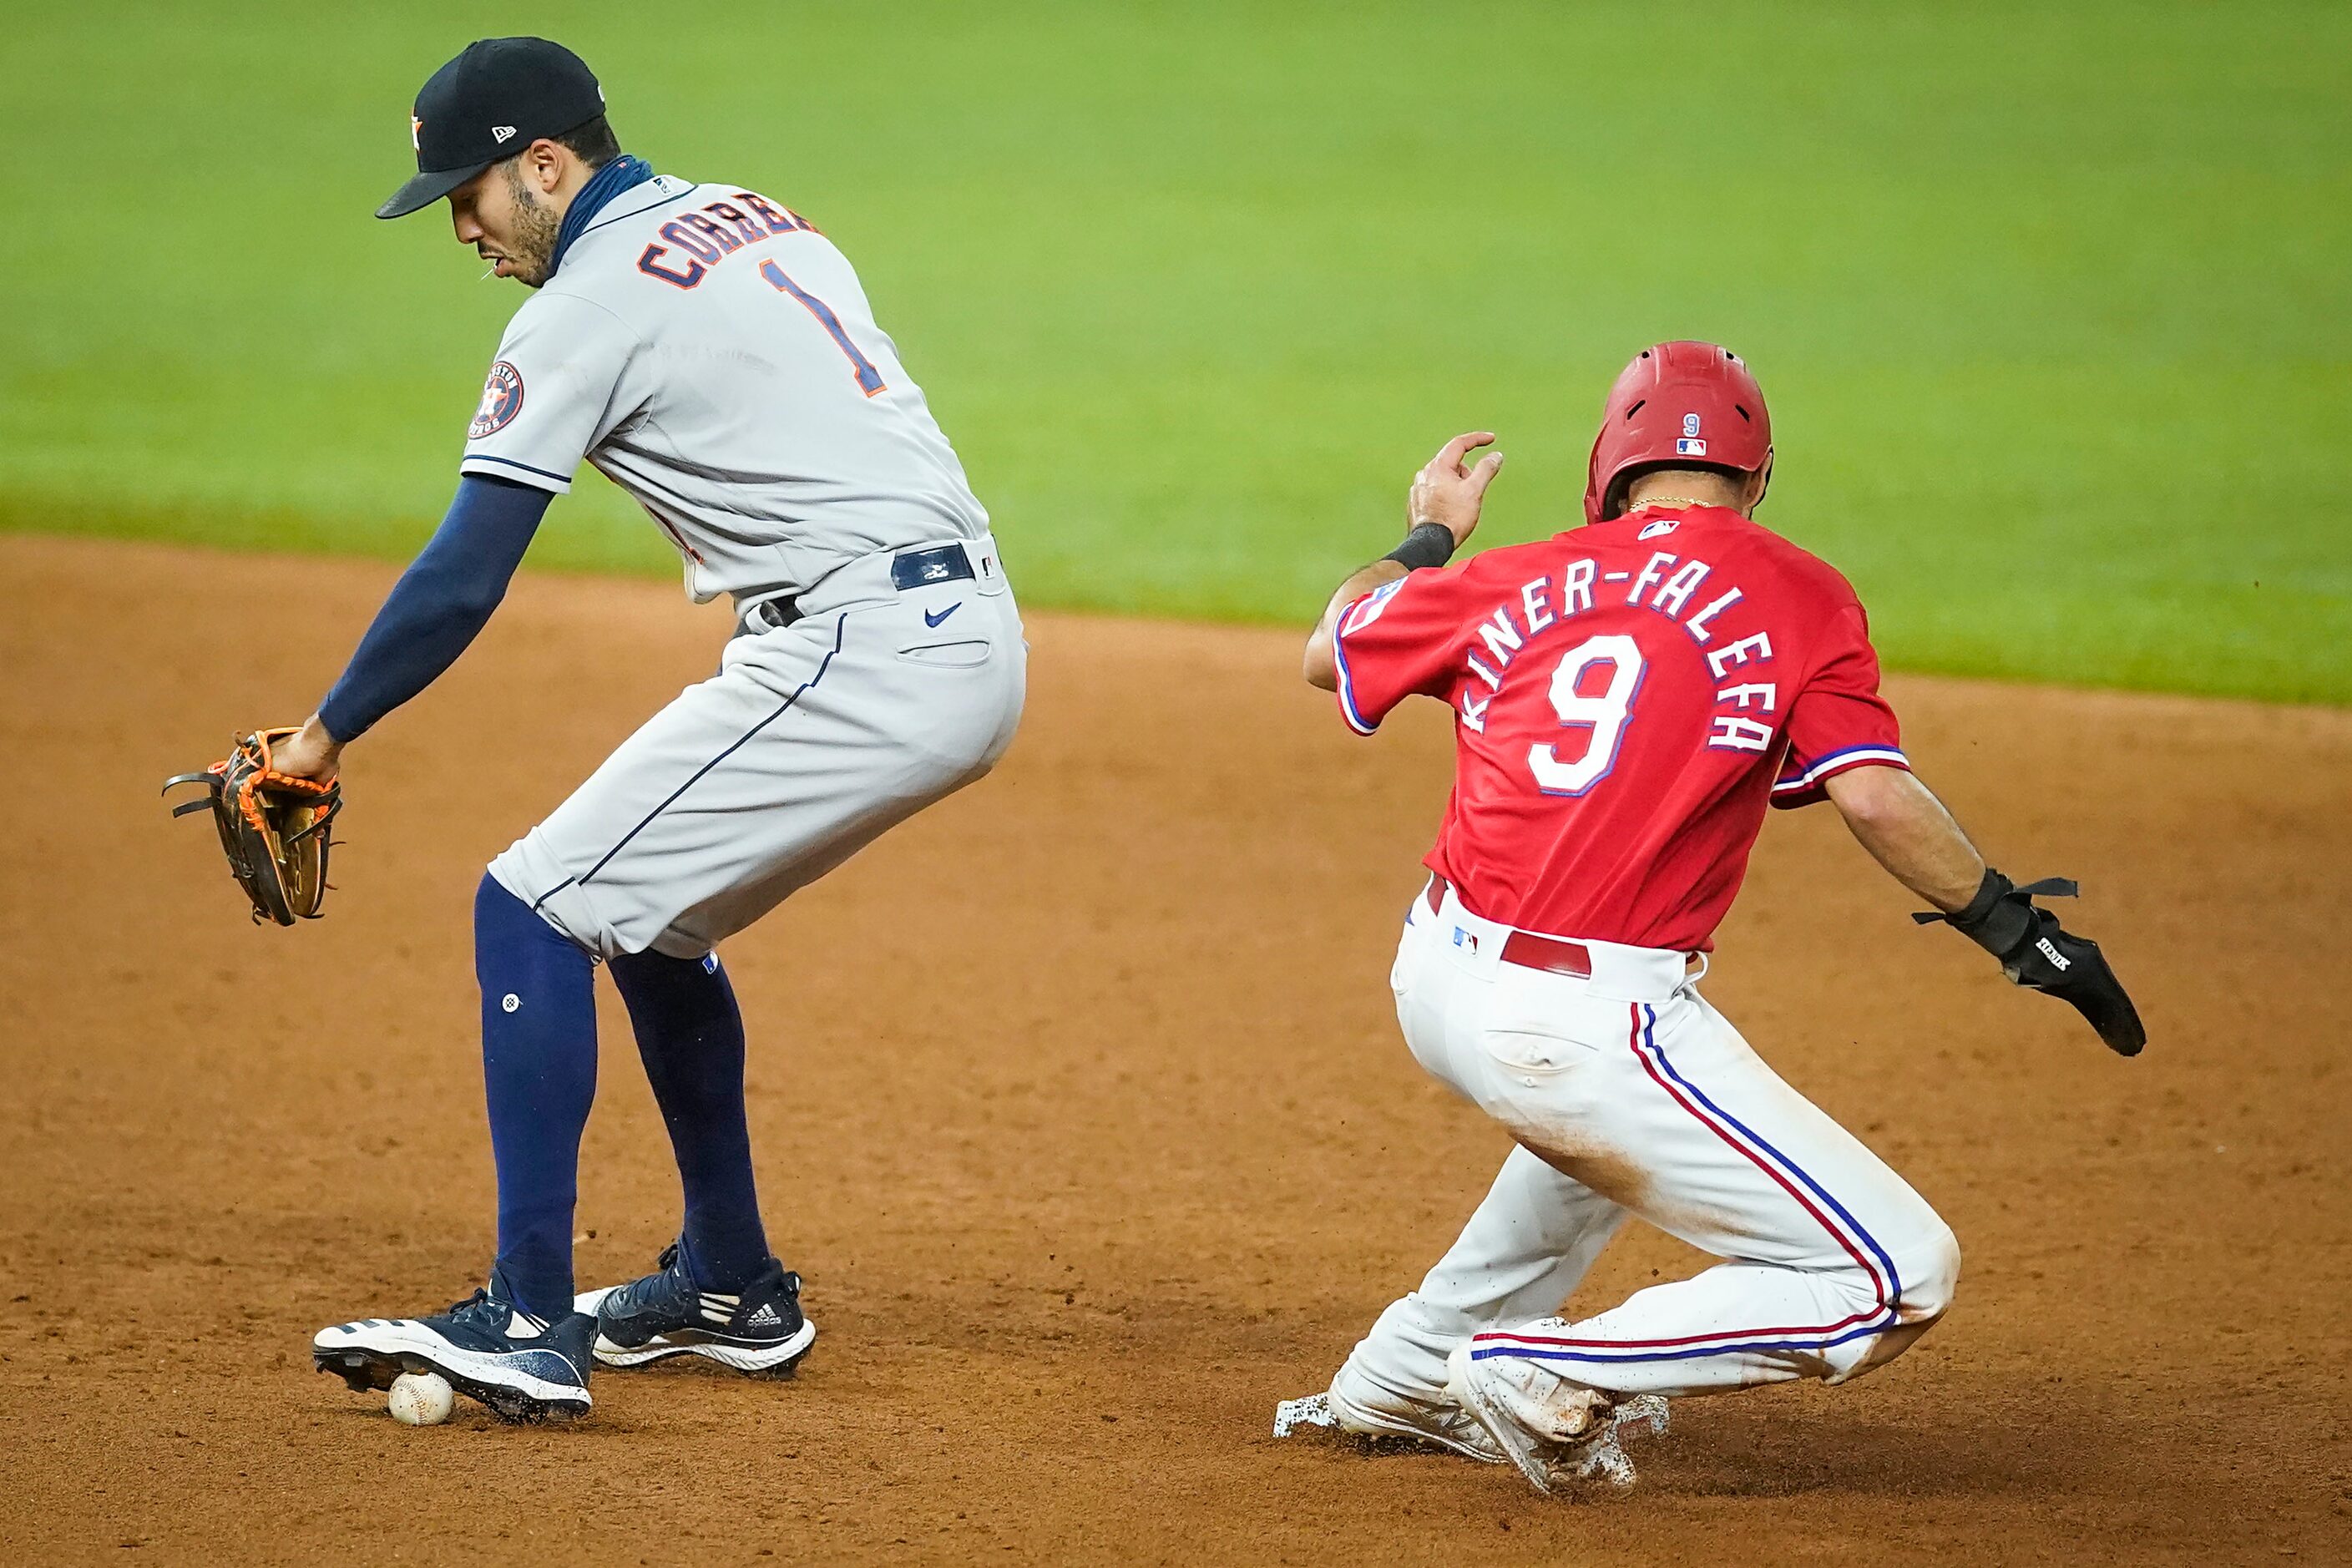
[277,38,1025,1420]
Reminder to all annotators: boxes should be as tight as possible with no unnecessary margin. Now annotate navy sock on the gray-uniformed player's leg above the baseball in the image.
[473,874,595,1321]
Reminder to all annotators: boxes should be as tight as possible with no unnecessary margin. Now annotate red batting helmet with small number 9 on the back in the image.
[1586,343,1771,522]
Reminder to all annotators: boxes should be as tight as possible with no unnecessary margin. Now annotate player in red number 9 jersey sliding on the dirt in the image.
[1277,343,2145,1490]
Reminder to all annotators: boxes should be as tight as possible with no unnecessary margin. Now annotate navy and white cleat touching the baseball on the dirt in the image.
[311,1281,595,1422]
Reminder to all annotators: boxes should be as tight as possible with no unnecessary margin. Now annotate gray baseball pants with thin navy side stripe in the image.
[489,539,1028,959]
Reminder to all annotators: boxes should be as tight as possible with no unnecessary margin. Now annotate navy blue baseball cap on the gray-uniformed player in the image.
[377,38,604,219]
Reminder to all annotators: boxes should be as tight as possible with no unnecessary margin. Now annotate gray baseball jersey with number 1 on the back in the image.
[461,176,988,604]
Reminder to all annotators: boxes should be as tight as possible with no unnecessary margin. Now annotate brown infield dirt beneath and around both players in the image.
[0,536,2352,1563]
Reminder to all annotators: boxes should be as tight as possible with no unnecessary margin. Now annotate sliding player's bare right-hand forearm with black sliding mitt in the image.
[1823,769,2147,1055]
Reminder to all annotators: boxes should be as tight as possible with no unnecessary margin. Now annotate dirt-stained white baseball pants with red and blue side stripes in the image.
[1338,891,1960,1401]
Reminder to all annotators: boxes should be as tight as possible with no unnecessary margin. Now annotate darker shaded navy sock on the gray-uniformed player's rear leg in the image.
[611,952,766,1293]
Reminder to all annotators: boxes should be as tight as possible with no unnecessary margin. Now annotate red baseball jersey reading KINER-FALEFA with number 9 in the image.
[1333,505,1909,952]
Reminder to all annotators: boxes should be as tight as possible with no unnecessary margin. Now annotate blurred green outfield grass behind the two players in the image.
[0,0,2352,703]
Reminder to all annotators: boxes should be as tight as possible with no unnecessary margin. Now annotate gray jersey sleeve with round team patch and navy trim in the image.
[458,294,642,496]
